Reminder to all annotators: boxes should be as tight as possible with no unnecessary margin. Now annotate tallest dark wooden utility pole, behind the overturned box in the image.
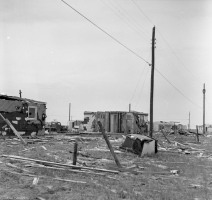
[149,26,155,137]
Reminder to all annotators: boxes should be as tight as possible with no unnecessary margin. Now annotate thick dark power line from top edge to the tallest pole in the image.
[61,0,151,66]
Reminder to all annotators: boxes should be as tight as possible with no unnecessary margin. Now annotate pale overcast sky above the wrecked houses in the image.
[0,0,212,128]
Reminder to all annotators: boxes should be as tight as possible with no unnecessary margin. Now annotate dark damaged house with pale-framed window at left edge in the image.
[0,95,46,136]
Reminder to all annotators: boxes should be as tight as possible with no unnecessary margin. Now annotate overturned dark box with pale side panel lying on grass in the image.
[120,134,157,156]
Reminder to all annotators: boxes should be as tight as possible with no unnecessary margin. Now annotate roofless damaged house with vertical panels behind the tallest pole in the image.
[83,111,148,134]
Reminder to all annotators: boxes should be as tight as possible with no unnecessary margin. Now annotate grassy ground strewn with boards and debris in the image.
[0,130,212,200]
